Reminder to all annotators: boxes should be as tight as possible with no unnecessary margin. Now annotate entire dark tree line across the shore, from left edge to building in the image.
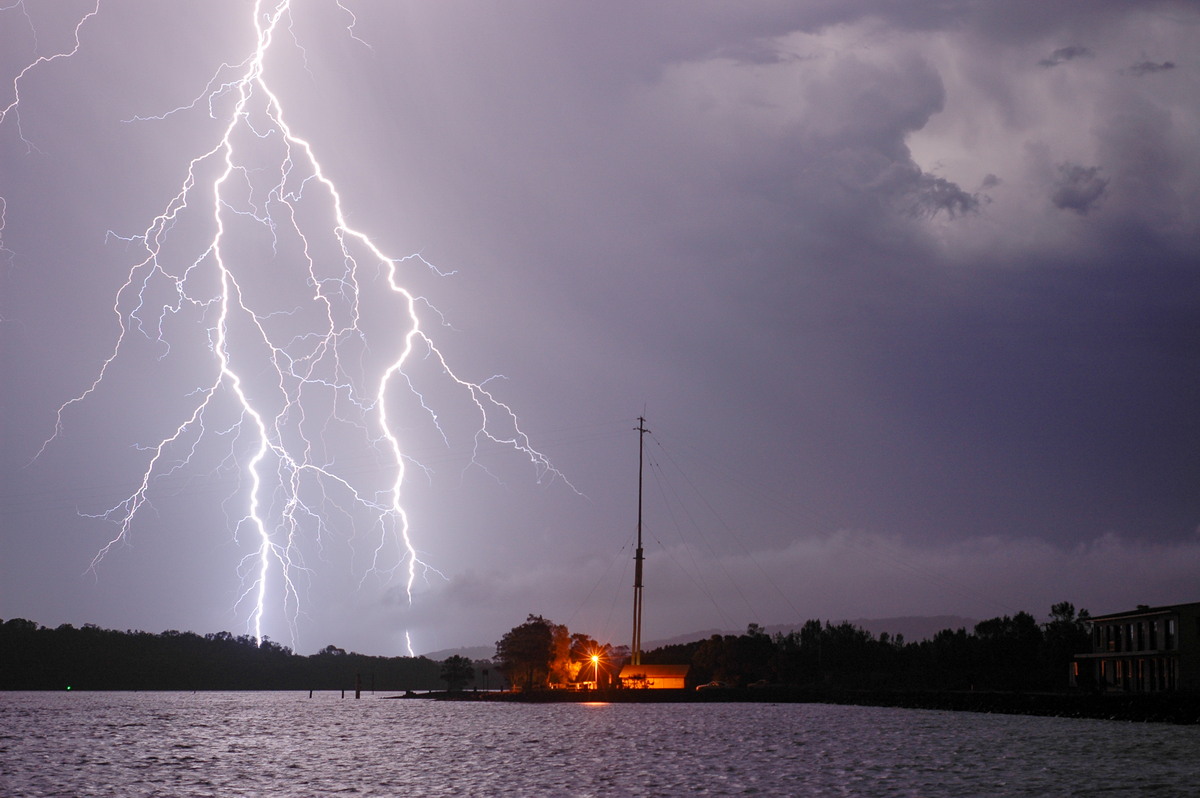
[0,601,1090,691]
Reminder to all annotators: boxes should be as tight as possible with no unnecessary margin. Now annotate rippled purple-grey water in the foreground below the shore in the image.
[0,692,1200,798]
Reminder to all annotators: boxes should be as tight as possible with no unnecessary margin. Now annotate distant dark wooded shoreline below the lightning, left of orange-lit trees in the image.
[0,618,488,691]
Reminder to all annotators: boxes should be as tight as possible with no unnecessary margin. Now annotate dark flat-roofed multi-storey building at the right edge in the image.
[1072,601,1200,692]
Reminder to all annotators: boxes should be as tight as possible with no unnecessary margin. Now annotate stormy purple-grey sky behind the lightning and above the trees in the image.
[0,0,1200,654]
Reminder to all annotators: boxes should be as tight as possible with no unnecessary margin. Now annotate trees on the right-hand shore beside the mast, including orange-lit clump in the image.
[496,601,1090,691]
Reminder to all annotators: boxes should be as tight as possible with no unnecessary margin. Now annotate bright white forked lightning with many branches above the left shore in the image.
[0,0,574,654]
